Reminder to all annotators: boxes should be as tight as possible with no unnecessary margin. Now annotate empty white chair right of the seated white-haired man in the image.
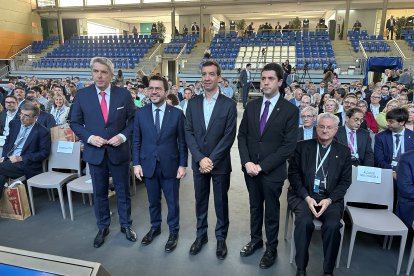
[345,167,408,275]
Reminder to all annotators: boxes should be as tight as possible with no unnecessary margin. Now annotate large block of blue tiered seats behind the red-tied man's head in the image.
[33,35,158,69]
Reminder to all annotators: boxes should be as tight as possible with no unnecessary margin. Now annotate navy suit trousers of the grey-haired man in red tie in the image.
[89,152,132,230]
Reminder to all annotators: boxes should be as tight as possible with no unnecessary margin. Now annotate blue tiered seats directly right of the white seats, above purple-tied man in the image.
[295,31,337,70]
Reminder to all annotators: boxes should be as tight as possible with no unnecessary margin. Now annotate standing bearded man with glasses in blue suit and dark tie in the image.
[132,75,188,253]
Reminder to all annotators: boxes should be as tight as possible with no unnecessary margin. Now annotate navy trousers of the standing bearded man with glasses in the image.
[145,163,180,234]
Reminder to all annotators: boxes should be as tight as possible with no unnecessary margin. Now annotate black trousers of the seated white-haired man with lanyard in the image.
[293,200,343,273]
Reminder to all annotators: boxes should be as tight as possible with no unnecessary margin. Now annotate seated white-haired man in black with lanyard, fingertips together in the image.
[288,113,352,276]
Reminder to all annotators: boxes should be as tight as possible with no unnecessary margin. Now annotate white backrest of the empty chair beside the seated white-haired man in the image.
[344,166,394,211]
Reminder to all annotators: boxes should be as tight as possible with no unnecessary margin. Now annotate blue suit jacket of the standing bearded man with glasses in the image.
[132,104,188,178]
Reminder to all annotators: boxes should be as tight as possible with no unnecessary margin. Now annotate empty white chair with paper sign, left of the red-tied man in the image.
[27,141,81,219]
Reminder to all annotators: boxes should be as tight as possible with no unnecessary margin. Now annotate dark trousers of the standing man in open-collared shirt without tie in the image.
[193,173,230,240]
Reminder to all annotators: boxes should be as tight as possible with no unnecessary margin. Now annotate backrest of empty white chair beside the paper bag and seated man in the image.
[48,141,81,176]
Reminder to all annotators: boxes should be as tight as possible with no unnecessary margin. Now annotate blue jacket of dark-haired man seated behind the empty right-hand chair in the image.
[374,128,414,169]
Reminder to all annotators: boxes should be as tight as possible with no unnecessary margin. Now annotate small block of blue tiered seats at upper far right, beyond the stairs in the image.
[348,30,391,52]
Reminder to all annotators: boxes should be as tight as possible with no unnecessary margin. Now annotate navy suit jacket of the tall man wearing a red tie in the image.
[70,85,135,165]
